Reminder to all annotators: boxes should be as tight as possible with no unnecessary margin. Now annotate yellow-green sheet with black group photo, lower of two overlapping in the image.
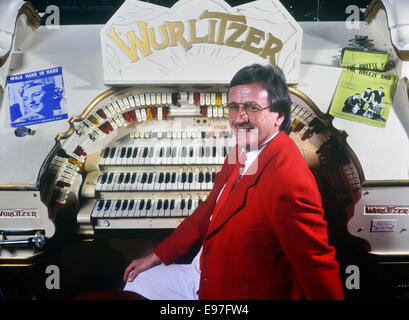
[329,69,398,128]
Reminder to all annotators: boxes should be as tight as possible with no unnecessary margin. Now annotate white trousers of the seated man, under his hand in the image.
[124,249,202,300]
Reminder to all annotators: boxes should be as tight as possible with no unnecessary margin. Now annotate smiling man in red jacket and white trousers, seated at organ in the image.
[124,65,344,299]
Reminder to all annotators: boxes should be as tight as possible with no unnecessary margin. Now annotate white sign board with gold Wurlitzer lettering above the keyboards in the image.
[101,0,302,85]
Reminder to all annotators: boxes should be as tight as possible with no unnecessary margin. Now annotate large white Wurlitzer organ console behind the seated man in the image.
[0,0,409,298]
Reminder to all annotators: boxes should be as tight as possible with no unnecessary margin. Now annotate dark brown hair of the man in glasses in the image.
[229,64,291,134]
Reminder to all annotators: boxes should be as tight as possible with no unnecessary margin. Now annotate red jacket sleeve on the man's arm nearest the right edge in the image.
[270,146,344,300]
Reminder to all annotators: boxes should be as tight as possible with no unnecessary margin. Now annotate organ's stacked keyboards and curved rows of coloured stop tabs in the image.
[50,86,360,231]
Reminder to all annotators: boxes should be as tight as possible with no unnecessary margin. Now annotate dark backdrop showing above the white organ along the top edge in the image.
[30,0,371,25]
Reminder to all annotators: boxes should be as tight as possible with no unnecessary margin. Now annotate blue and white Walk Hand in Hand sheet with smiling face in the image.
[7,67,68,127]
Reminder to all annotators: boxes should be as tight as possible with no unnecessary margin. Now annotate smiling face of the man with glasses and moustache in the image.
[229,83,284,149]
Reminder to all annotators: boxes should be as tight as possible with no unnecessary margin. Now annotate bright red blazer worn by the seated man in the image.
[155,132,344,299]
